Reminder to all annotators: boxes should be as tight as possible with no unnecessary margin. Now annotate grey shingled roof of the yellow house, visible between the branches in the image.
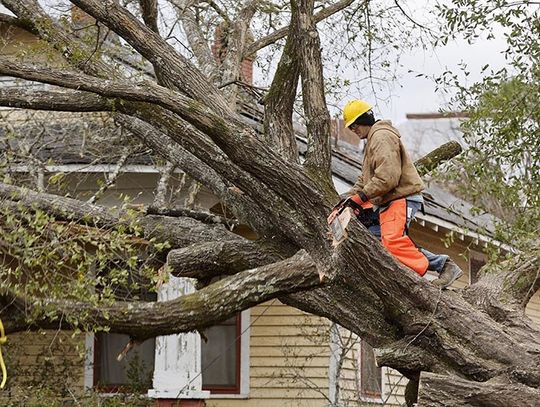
[0,99,496,242]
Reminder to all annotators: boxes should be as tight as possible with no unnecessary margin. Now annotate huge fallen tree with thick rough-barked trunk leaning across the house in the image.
[0,0,540,406]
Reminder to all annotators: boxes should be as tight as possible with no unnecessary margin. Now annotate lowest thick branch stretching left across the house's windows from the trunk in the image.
[2,251,320,341]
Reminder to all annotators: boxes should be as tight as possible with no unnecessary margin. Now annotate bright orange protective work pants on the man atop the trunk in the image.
[379,198,429,276]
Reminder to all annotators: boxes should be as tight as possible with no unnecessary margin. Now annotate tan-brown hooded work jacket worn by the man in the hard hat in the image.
[350,121,424,205]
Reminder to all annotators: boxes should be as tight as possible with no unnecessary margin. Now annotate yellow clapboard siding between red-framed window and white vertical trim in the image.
[207,300,330,407]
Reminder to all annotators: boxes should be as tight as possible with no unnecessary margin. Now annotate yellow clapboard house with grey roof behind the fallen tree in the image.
[0,11,540,407]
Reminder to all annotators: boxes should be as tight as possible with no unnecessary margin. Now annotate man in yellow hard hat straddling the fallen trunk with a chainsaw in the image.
[338,100,463,289]
